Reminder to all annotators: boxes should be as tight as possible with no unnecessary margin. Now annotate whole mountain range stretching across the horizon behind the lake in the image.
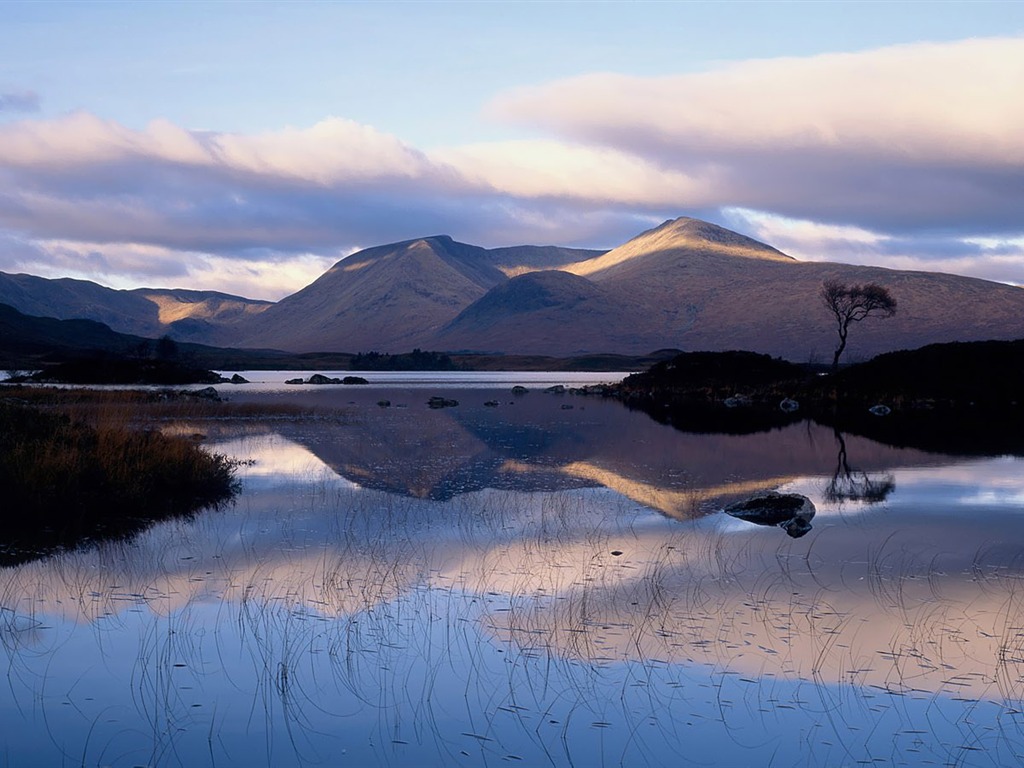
[0,217,1024,361]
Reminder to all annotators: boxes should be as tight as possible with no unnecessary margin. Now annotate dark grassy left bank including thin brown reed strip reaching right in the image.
[0,384,331,566]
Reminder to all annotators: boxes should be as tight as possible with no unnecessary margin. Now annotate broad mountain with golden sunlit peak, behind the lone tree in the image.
[436,218,1024,361]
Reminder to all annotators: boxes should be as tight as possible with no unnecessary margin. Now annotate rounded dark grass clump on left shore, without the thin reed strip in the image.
[0,387,236,565]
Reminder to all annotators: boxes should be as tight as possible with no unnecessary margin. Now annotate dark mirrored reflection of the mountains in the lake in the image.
[224,390,948,518]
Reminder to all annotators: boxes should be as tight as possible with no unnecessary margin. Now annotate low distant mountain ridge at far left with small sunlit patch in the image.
[0,272,272,343]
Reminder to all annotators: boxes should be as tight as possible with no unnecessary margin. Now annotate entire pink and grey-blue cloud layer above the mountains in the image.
[0,38,1024,298]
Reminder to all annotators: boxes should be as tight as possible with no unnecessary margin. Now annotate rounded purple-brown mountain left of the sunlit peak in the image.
[234,236,603,352]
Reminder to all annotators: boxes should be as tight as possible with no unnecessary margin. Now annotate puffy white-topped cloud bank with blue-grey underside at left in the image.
[0,113,472,253]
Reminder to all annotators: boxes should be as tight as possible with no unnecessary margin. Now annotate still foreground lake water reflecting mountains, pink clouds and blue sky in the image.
[0,382,1024,766]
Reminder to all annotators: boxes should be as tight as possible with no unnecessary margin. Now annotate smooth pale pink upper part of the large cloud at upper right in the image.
[490,37,1024,165]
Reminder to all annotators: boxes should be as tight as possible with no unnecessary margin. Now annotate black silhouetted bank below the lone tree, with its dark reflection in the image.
[611,340,1024,455]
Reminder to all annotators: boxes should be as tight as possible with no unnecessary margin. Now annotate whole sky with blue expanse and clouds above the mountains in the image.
[0,0,1024,300]
